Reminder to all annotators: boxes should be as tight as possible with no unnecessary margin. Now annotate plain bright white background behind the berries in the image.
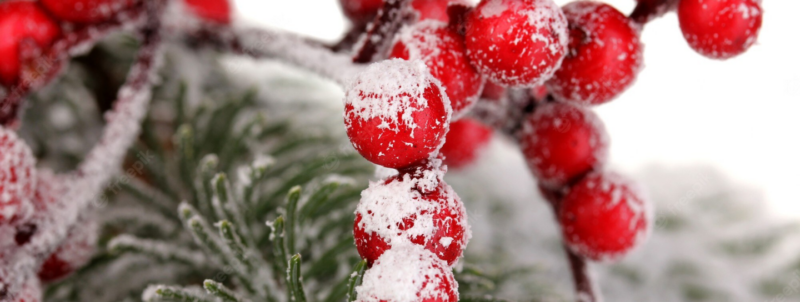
[230,0,800,218]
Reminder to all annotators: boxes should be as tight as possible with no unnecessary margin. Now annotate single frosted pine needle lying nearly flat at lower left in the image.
[108,235,205,267]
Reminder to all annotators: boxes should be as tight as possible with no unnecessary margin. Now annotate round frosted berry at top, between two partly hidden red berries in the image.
[466,0,569,87]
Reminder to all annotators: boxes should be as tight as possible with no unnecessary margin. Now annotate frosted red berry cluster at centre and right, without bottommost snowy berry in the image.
[341,0,761,301]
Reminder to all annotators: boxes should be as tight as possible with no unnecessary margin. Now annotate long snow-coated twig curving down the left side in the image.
[0,0,165,293]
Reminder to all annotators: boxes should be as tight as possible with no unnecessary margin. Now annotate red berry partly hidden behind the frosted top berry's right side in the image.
[547,1,642,105]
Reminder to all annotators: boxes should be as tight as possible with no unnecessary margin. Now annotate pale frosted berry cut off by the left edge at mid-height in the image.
[0,127,36,224]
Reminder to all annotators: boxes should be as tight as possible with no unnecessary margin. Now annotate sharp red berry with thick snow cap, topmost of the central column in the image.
[344,59,452,169]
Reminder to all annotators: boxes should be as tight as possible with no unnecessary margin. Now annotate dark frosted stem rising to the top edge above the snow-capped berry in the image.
[353,0,413,63]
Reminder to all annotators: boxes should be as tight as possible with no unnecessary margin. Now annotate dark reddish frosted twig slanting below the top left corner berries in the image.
[0,3,144,126]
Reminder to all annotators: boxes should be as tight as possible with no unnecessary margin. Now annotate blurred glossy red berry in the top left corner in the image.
[0,0,61,87]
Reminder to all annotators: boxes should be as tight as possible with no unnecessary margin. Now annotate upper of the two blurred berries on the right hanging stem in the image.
[521,103,608,189]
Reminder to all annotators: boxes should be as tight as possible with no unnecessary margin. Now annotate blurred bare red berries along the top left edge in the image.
[0,0,231,94]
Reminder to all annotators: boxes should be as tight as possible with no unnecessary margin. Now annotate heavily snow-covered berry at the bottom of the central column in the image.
[356,244,458,302]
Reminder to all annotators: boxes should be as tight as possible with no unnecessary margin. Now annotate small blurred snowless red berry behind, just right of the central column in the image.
[442,118,494,169]
